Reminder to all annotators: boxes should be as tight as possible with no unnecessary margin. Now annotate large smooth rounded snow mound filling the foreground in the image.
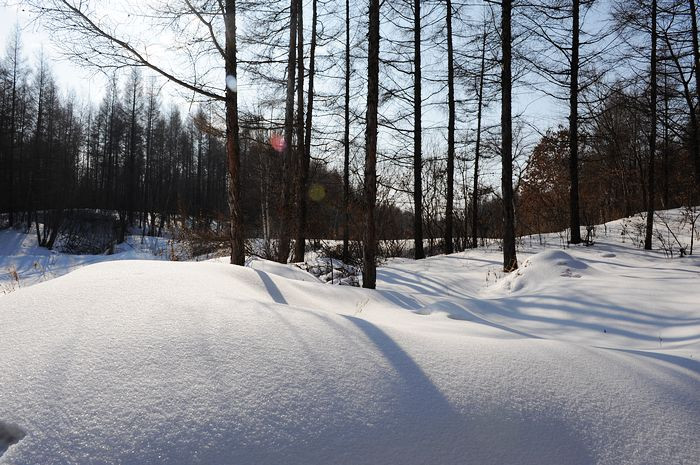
[0,260,700,465]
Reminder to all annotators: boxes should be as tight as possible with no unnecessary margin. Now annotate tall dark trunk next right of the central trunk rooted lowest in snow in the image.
[413,0,425,260]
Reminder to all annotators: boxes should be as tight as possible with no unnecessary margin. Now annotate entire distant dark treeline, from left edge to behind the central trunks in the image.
[0,32,412,248]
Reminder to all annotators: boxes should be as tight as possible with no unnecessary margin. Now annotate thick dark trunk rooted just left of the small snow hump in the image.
[501,0,518,272]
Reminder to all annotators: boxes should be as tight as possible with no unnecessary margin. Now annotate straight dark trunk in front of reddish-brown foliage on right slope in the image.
[569,0,581,244]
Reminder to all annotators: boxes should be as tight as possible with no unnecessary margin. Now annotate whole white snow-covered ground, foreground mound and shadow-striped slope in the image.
[0,211,700,465]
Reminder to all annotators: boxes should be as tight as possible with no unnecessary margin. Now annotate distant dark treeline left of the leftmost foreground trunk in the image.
[0,46,232,248]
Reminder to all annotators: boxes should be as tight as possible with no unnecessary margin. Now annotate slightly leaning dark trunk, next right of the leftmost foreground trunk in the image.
[277,0,301,263]
